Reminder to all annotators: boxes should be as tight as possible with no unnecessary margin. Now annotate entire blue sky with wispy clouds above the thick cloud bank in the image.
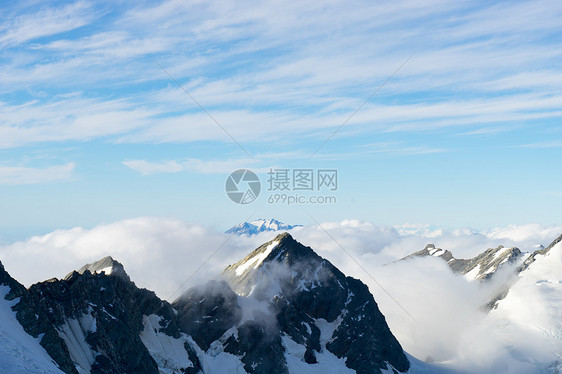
[0,0,562,241]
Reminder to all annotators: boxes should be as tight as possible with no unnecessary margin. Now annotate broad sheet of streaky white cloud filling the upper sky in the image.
[0,1,562,153]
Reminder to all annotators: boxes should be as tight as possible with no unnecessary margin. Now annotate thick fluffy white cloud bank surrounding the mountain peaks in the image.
[0,217,562,373]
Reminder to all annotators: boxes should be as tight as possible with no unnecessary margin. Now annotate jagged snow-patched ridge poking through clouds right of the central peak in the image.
[402,244,525,281]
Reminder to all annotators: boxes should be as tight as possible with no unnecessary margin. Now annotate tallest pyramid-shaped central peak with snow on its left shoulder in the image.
[215,233,409,374]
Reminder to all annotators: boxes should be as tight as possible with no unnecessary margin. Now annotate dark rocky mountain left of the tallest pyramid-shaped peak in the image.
[0,258,200,374]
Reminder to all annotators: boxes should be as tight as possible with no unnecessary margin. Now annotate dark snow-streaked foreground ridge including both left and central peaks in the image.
[0,234,410,374]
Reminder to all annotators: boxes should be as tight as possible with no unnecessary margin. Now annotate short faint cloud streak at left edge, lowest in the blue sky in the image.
[0,163,75,185]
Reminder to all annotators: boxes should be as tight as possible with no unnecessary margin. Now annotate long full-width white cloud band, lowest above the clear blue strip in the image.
[0,92,562,153]
